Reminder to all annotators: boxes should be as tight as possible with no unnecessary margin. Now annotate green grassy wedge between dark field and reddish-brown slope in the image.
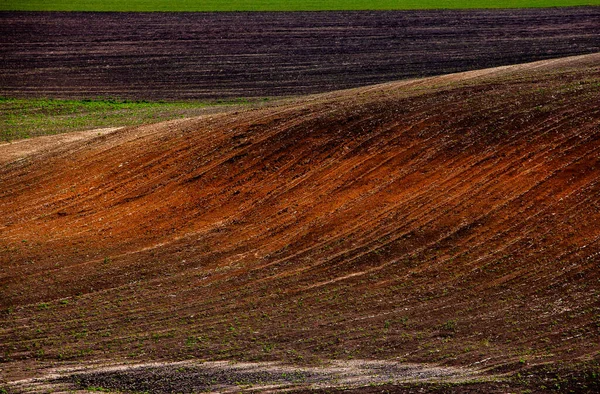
[0,97,264,141]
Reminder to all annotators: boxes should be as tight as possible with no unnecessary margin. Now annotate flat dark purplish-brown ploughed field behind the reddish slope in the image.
[0,7,600,99]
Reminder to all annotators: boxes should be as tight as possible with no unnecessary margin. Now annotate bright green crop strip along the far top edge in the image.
[0,0,600,11]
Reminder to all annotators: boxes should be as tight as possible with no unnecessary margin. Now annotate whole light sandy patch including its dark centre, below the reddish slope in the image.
[8,360,478,393]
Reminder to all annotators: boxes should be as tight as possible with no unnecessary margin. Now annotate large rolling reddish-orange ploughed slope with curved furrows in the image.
[0,54,600,390]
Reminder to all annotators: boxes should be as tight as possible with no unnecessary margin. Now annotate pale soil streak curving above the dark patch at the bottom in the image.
[7,360,482,393]
